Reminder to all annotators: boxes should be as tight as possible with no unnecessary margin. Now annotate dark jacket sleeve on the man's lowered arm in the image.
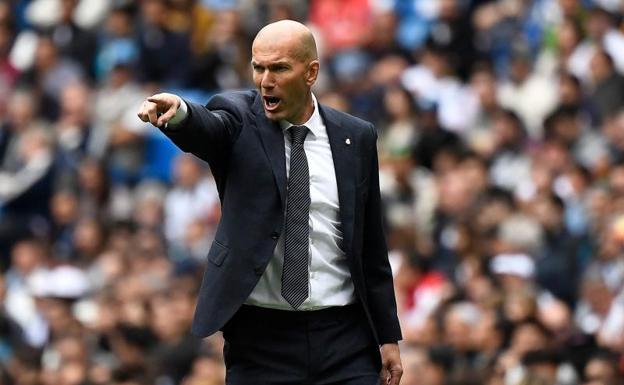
[362,125,402,344]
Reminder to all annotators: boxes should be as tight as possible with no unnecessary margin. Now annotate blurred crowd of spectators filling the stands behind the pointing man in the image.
[0,0,624,385]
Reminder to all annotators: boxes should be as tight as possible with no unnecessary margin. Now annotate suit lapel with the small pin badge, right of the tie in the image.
[319,105,357,255]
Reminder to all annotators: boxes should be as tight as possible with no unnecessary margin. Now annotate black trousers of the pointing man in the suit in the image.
[223,305,381,385]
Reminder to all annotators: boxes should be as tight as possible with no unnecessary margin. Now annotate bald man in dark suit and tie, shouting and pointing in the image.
[138,20,402,385]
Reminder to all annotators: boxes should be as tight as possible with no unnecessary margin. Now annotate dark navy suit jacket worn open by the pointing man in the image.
[163,91,401,344]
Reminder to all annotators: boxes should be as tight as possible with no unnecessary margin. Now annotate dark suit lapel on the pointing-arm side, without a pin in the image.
[252,94,286,208]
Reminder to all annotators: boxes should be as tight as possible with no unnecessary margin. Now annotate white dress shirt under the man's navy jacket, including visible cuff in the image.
[170,95,355,310]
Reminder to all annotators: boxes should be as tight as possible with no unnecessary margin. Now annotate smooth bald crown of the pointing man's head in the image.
[253,20,318,63]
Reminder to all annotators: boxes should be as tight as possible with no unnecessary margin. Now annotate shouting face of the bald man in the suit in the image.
[251,40,319,124]
